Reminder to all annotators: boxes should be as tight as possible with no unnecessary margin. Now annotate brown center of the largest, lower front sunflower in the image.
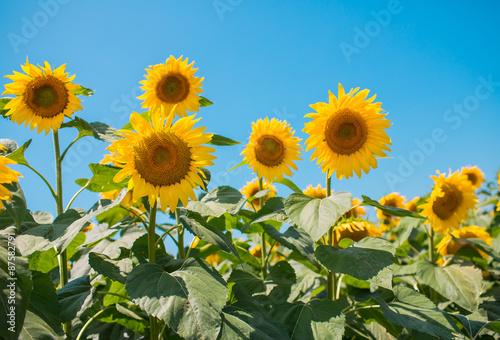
[134,132,191,186]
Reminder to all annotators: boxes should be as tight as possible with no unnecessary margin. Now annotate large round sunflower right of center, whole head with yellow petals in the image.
[303,84,391,179]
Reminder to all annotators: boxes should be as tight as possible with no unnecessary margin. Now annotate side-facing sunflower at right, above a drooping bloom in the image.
[420,171,477,234]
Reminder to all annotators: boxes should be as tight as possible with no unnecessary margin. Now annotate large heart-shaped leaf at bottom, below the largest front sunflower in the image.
[126,258,229,339]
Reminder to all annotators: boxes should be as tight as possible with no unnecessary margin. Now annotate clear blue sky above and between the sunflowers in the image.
[0,0,500,218]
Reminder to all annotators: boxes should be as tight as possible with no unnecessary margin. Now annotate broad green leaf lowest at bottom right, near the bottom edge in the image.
[380,286,458,339]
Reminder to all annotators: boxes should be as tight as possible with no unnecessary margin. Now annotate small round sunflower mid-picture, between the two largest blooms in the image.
[241,118,301,182]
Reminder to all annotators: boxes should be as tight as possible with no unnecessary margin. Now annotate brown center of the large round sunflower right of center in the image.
[325,109,368,155]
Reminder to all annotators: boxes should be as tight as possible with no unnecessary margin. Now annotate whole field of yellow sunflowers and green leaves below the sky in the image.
[0,56,500,340]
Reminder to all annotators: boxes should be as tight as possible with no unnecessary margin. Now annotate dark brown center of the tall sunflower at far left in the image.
[24,76,69,118]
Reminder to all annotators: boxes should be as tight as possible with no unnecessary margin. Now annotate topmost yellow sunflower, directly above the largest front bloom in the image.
[137,56,203,117]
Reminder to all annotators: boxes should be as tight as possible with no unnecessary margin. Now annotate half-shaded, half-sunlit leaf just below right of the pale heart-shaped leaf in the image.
[315,237,395,289]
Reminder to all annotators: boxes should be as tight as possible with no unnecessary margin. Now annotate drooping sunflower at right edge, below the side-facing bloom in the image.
[436,225,492,259]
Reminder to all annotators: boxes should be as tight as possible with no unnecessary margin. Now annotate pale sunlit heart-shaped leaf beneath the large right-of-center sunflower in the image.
[285,191,352,242]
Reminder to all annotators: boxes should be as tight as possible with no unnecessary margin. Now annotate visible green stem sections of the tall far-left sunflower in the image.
[52,131,73,340]
